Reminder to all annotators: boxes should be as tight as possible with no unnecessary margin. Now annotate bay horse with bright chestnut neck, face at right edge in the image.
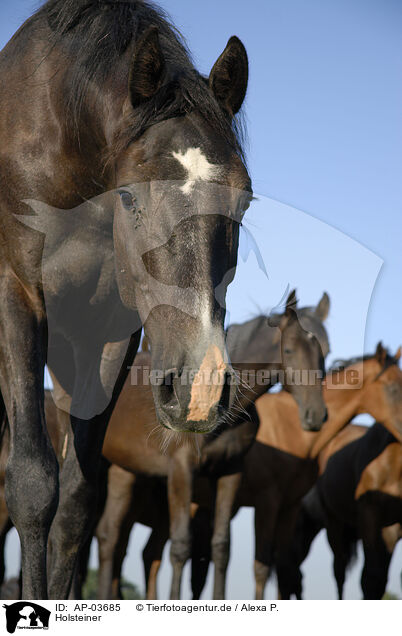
[189,343,402,599]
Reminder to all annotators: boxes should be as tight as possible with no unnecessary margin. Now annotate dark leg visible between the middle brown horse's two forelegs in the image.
[191,507,212,600]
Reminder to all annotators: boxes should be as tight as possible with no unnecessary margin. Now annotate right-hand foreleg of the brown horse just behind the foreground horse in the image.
[211,473,241,599]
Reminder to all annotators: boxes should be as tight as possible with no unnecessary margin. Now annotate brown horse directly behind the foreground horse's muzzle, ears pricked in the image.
[78,292,329,598]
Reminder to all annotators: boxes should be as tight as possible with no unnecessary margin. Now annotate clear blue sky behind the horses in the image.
[0,0,402,598]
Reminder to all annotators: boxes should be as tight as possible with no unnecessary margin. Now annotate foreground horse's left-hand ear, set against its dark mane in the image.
[128,26,165,108]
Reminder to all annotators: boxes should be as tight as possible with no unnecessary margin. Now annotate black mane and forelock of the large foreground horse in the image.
[34,0,244,159]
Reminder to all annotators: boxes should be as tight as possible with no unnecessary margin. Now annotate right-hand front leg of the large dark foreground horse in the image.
[49,332,140,599]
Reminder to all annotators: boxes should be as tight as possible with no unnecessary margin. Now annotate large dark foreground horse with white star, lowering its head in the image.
[0,0,251,599]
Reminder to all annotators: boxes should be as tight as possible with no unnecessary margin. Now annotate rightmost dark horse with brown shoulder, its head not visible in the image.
[294,423,402,599]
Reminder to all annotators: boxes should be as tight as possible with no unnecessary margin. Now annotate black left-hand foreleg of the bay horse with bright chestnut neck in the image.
[254,492,278,601]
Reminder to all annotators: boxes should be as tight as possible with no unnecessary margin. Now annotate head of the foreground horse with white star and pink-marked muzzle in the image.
[114,28,250,432]
